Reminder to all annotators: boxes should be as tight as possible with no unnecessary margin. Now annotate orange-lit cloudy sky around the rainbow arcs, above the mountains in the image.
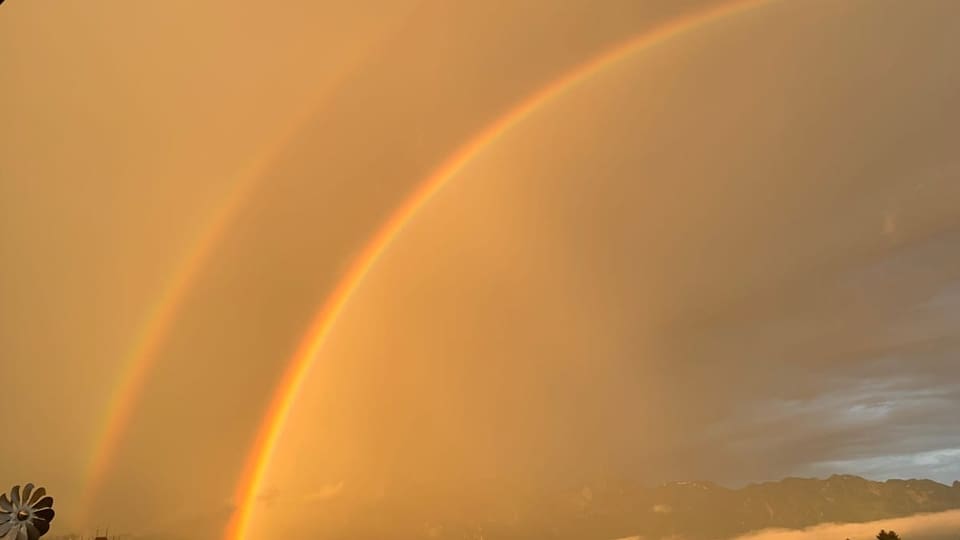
[0,0,960,538]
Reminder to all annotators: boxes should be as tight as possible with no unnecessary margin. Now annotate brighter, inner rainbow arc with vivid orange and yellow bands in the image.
[224,0,775,540]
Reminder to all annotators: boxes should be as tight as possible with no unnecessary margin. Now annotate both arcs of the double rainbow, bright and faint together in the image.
[73,0,777,540]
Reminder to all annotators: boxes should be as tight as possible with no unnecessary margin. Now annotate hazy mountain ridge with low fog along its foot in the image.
[378,475,960,540]
